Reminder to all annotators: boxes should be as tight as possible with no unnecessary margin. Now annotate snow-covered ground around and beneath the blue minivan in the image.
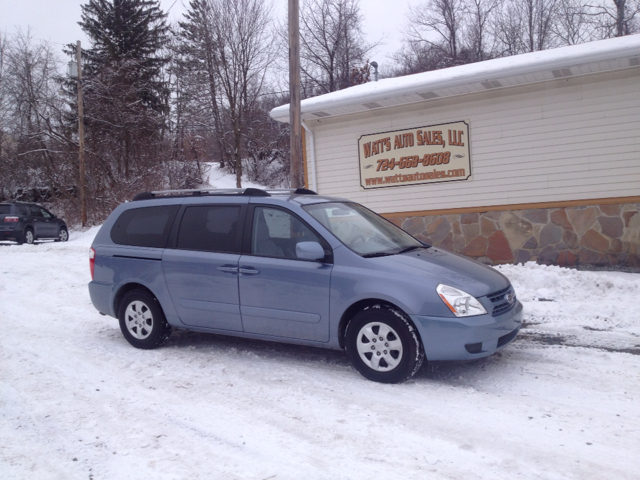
[0,232,640,480]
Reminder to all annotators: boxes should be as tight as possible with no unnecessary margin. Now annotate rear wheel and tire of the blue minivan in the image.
[118,290,171,350]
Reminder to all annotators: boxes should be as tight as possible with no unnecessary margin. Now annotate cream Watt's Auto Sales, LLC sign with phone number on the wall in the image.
[358,122,471,189]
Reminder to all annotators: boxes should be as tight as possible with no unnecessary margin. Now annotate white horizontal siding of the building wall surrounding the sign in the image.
[307,68,640,213]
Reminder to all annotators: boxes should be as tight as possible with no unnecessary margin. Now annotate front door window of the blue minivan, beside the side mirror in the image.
[251,207,325,259]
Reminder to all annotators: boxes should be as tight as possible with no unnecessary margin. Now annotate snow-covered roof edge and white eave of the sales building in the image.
[270,34,640,122]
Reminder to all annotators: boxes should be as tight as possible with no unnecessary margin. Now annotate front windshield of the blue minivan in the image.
[303,202,425,257]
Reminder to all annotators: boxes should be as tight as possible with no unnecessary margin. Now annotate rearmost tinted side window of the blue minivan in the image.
[111,205,180,248]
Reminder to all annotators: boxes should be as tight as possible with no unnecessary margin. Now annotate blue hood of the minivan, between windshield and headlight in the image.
[369,247,510,297]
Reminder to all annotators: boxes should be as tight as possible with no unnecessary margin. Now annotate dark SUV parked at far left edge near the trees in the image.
[0,202,69,244]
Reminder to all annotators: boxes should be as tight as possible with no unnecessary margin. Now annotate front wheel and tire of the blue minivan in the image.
[345,305,424,383]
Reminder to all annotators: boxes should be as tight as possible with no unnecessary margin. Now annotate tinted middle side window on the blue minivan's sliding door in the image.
[177,205,240,253]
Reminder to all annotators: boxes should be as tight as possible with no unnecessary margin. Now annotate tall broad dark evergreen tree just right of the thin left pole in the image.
[68,0,170,216]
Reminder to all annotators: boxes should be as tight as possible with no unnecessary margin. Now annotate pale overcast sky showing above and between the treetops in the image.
[0,0,412,66]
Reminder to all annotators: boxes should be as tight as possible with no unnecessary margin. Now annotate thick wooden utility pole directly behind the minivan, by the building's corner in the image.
[289,0,304,188]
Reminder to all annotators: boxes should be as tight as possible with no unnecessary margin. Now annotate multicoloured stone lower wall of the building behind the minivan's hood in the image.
[387,203,640,269]
